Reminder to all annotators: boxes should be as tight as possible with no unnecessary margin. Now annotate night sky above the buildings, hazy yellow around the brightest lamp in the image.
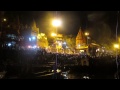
[5,11,120,35]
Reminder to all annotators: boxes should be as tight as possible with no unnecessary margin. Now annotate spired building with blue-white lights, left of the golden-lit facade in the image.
[20,19,39,47]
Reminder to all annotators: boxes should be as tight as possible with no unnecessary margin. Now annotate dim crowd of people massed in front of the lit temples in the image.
[0,49,120,79]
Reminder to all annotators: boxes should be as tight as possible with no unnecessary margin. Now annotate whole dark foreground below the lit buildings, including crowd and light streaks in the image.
[0,50,120,79]
